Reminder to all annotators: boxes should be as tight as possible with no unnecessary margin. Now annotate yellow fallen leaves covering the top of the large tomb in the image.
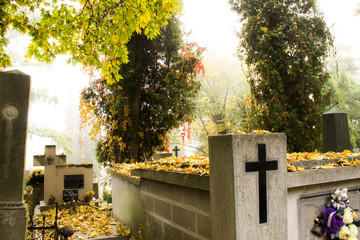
[111,150,360,175]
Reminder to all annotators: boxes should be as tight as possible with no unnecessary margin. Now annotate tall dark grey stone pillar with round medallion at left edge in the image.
[0,70,30,240]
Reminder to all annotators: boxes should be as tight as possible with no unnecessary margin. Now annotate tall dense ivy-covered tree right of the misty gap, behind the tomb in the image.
[230,0,332,151]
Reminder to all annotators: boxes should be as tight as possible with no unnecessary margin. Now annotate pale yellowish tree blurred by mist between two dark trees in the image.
[191,56,250,154]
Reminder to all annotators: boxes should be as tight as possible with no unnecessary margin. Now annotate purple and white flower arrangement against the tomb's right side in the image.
[311,188,360,240]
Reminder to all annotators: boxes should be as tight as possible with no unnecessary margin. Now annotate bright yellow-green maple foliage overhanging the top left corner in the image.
[0,0,180,77]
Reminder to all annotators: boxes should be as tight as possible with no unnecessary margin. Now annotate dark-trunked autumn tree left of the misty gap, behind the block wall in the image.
[82,17,201,162]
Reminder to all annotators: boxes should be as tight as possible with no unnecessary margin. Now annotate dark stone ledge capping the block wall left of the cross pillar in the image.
[131,169,210,191]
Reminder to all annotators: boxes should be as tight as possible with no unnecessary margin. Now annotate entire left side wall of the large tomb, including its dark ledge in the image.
[112,170,210,240]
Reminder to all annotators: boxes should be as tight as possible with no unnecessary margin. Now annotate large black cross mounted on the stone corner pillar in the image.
[245,144,278,223]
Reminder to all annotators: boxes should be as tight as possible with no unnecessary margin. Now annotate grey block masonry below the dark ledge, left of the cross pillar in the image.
[141,179,210,240]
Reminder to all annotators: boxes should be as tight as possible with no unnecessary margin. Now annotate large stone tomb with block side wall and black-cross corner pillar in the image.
[112,133,360,240]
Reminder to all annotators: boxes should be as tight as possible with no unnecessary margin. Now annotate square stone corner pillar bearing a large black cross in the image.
[209,133,287,240]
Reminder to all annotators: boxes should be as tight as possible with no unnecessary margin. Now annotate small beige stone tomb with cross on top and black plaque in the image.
[34,145,93,202]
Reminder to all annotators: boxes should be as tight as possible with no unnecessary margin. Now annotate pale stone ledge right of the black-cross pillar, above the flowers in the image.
[287,166,360,188]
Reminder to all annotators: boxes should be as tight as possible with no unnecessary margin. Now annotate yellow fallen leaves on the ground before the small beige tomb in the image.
[27,203,141,240]
